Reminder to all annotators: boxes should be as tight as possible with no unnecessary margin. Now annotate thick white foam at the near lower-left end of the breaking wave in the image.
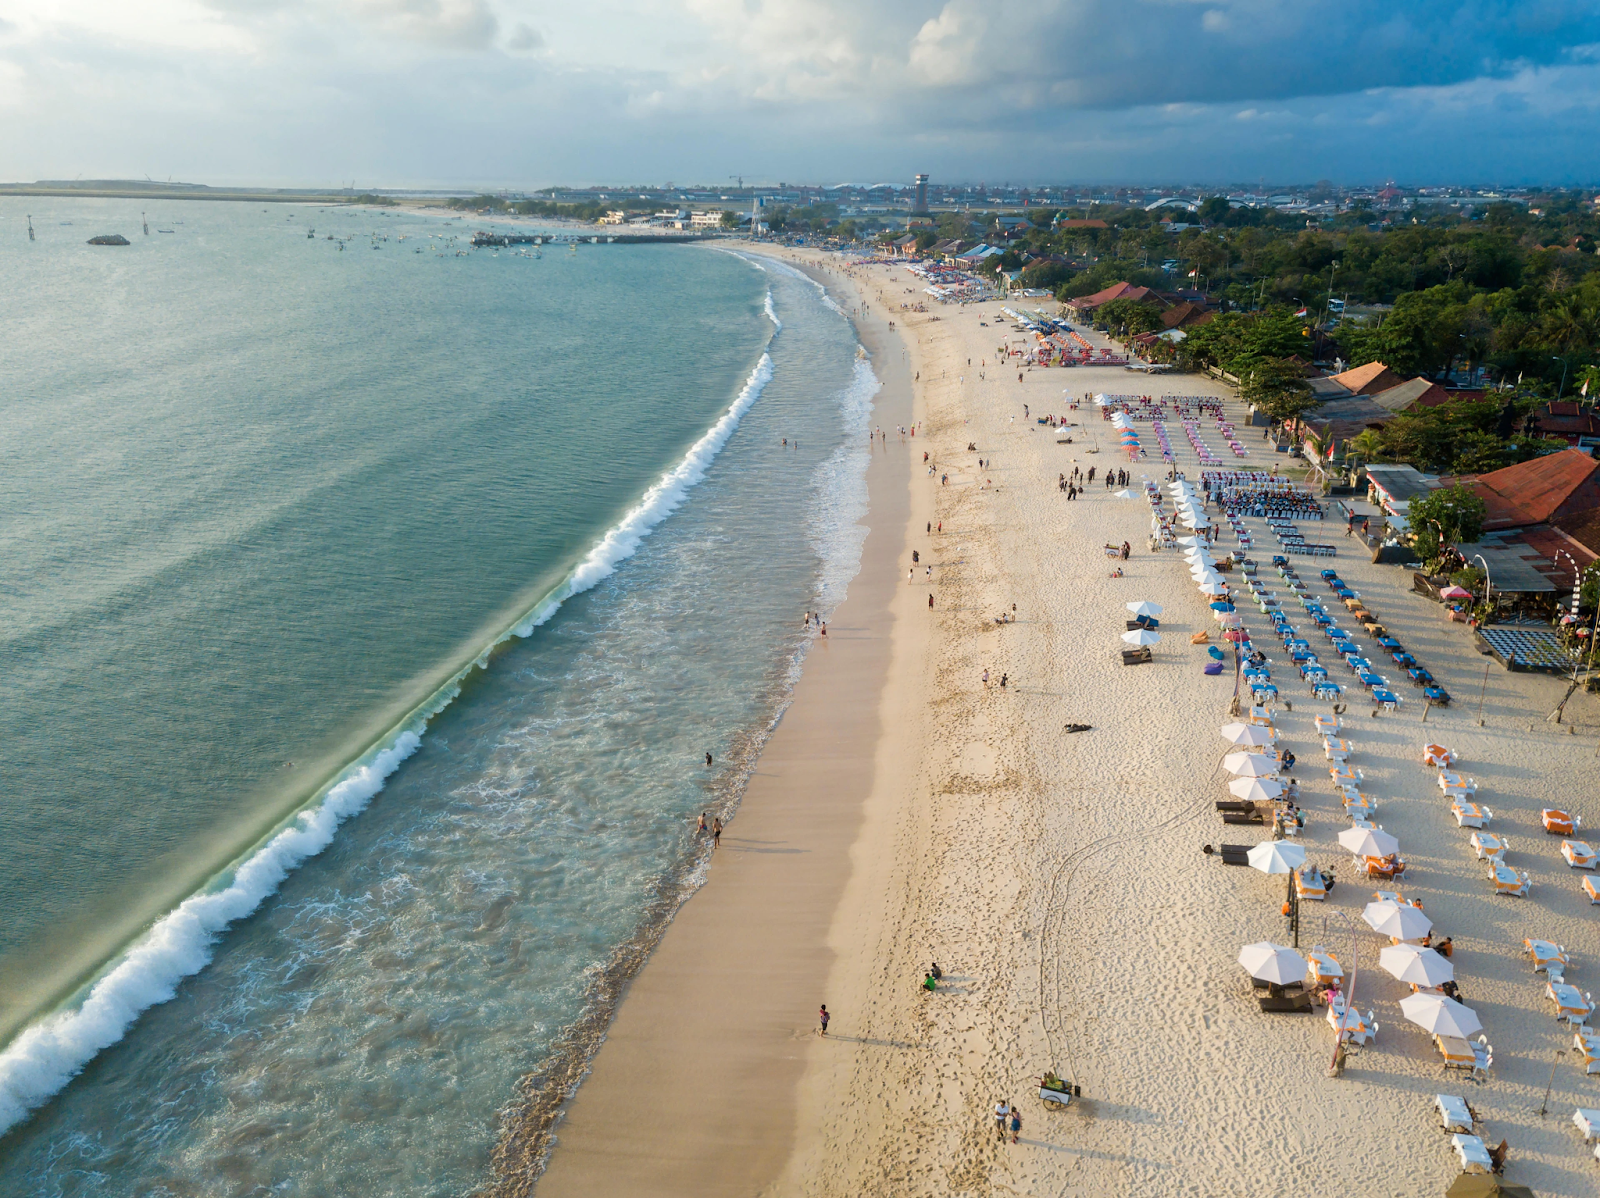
[0,731,422,1132]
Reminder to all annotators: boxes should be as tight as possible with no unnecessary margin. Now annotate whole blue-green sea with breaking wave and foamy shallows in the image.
[0,198,877,1196]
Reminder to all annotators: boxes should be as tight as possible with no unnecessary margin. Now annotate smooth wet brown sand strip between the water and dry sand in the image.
[536,248,920,1198]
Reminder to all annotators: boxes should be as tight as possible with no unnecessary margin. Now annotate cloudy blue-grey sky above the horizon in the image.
[0,0,1600,189]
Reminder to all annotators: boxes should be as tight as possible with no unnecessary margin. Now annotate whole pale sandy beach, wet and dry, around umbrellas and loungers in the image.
[539,254,1600,1196]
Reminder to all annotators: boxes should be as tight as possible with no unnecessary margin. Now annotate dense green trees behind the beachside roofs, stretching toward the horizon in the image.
[918,194,1600,395]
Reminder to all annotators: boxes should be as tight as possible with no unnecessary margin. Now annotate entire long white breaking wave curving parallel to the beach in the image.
[0,343,781,1134]
